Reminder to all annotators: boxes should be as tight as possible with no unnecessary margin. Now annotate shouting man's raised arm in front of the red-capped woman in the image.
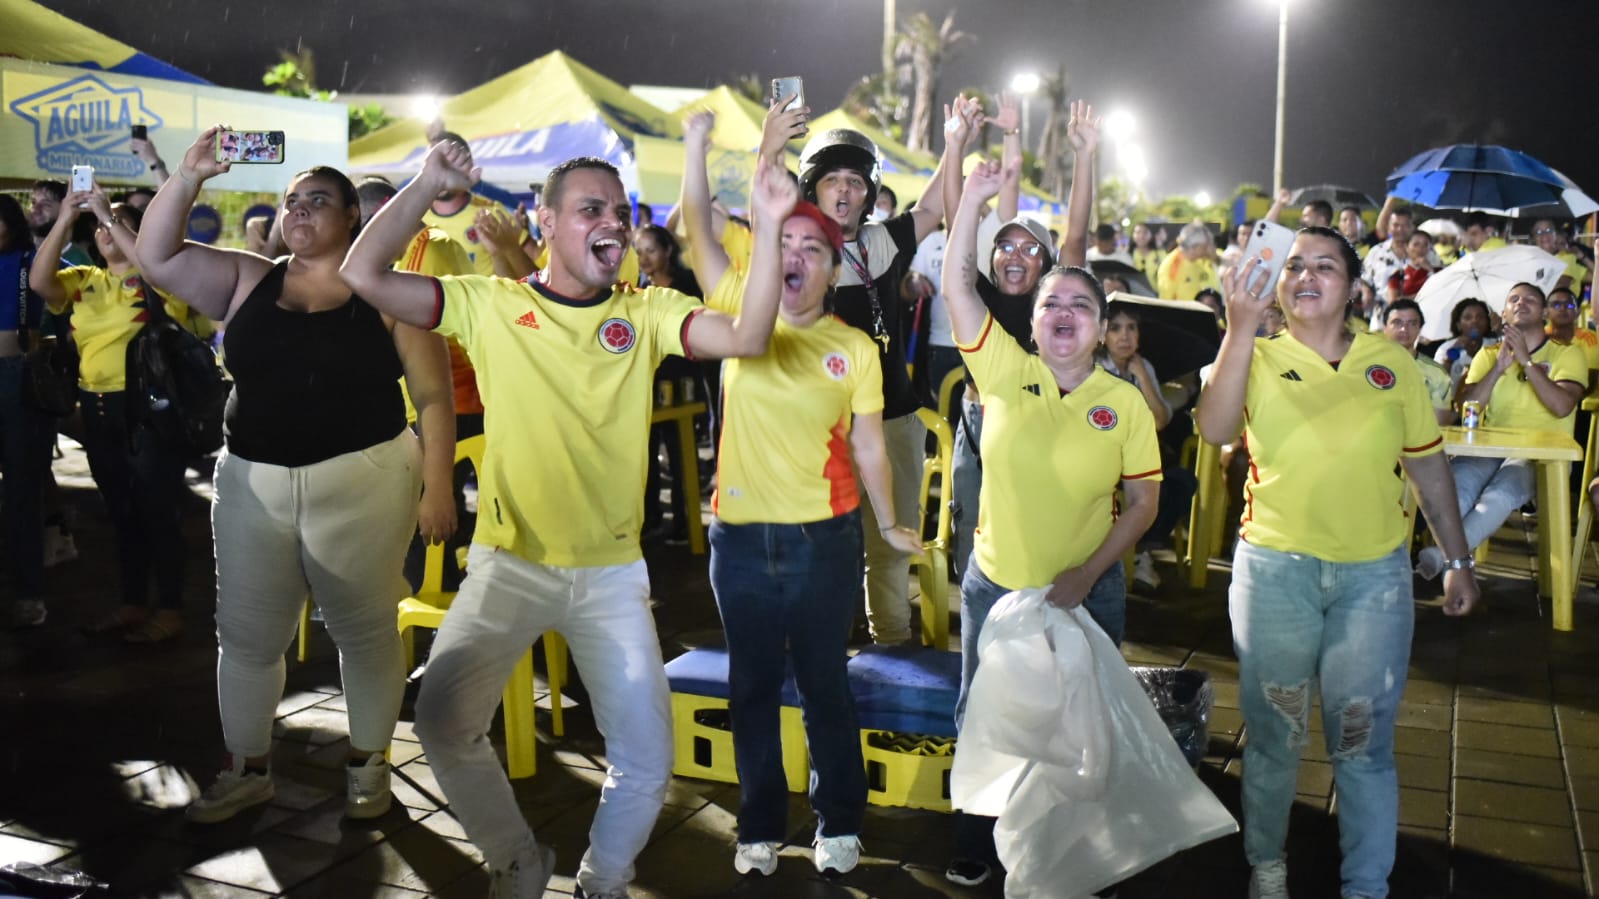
[684,162,800,358]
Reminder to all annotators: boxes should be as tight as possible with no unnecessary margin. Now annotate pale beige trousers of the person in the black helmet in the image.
[855,413,927,643]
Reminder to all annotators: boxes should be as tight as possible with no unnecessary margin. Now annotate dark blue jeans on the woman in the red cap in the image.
[710,512,867,843]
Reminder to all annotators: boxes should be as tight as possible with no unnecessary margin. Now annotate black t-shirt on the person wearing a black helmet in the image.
[833,213,929,419]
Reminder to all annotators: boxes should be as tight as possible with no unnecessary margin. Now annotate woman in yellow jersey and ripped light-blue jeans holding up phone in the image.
[1194,227,1477,899]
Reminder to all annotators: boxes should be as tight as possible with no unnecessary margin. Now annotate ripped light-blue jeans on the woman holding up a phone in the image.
[1228,541,1415,899]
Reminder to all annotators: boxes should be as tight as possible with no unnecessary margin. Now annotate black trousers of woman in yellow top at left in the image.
[78,390,189,609]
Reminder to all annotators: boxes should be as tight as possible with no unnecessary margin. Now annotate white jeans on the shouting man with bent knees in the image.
[416,544,672,896]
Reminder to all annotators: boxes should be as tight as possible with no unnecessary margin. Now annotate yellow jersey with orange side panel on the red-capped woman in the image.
[708,270,883,525]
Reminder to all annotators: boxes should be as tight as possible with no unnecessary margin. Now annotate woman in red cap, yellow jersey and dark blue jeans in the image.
[683,104,921,875]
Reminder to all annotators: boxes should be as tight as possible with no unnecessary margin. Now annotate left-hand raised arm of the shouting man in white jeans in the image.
[339,141,483,328]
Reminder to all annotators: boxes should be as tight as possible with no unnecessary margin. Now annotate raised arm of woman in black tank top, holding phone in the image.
[138,125,272,322]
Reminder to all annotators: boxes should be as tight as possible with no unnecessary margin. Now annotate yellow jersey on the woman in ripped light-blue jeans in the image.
[1238,331,1444,561]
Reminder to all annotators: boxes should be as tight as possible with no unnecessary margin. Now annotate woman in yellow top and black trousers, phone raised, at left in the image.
[29,186,206,643]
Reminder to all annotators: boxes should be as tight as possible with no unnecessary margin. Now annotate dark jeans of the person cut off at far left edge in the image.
[0,355,56,600]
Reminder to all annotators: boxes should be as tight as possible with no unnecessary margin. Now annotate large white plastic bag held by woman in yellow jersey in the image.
[950,589,1238,899]
